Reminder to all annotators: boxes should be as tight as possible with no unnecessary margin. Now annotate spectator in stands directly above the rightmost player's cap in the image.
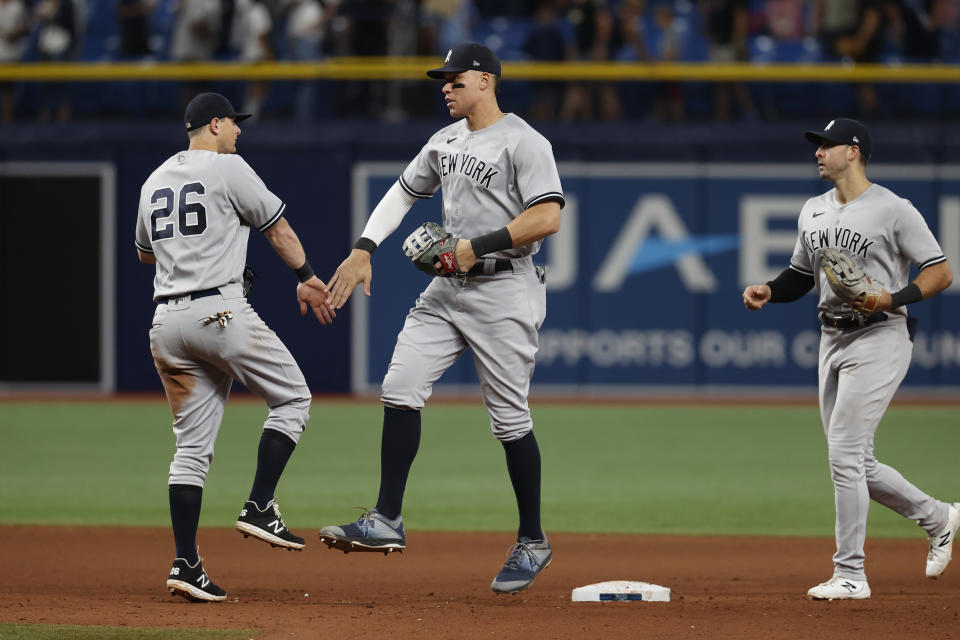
[814,0,886,117]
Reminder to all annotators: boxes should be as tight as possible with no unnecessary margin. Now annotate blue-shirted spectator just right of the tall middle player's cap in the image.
[523,0,575,120]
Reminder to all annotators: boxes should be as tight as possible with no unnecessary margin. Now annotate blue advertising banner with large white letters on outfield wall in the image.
[351,162,960,393]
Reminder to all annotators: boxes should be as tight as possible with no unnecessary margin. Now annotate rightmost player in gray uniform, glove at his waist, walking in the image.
[743,118,960,600]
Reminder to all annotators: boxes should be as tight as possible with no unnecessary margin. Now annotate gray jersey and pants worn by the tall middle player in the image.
[381,114,563,442]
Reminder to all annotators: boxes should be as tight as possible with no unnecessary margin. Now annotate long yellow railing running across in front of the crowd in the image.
[0,58,960,83]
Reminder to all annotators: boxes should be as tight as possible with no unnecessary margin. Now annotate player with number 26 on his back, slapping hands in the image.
[136,93,334,602]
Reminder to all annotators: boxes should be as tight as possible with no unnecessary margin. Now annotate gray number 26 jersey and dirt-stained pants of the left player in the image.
[136,151,310,487]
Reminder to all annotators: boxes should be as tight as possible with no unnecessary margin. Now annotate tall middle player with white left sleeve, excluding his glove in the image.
[308,43,563,593]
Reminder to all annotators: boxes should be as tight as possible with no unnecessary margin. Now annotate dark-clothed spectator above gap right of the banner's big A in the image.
[697,0,756,122]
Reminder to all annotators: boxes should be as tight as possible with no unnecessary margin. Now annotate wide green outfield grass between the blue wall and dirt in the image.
[0,399,960,537]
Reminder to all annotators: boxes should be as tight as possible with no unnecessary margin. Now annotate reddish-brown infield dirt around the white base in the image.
[0,526,960,640]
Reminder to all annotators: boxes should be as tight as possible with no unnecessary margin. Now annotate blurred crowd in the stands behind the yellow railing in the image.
[0,0,960,121]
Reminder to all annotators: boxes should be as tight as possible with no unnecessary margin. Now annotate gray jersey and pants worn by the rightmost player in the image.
[790,184,949,580]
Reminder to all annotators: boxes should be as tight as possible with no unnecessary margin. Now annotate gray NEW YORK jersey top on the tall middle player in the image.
[400,113,563,258]
